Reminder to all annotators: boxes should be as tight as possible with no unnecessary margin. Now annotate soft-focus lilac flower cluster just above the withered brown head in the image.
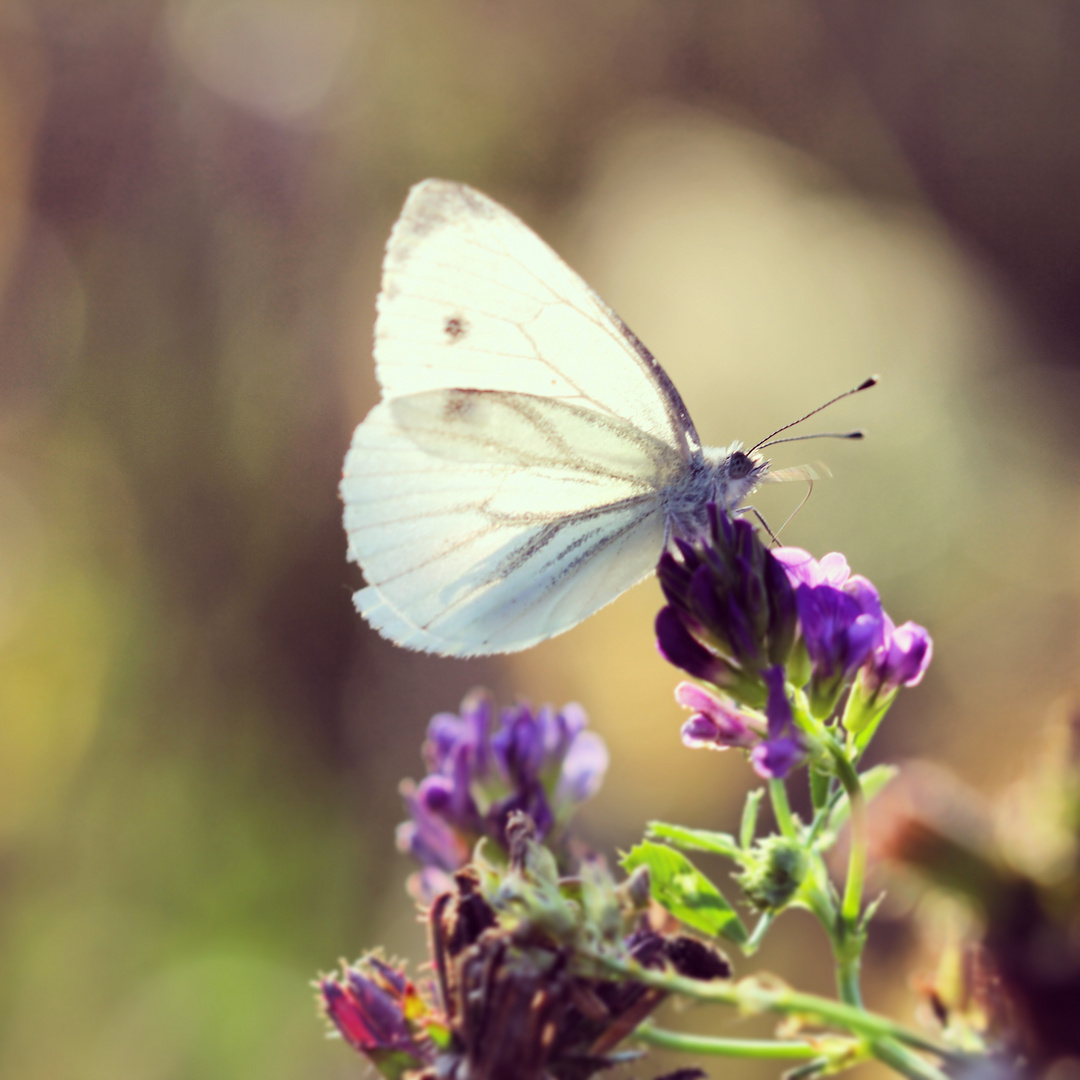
[397,690,608,902]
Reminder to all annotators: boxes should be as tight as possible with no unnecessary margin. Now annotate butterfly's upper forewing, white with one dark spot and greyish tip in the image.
[375,180,699,455]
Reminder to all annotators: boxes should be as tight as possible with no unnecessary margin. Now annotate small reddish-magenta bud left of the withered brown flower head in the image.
[319,956,434,1075]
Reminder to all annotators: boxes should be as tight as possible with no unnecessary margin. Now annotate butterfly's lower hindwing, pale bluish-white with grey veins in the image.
[341,390,685,656]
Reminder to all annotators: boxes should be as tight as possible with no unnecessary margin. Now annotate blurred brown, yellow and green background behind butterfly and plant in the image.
[0,0,1080,1080]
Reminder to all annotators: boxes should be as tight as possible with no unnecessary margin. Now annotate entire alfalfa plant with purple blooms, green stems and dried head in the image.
[319,507,1054,1080]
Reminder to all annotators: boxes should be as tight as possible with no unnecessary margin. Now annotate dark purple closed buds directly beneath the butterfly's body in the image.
[656,503,796,706]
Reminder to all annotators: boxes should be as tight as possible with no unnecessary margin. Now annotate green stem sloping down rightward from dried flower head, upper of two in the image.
[594,956,968,1062]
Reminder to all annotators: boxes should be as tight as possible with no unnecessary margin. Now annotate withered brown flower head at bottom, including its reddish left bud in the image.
[320,812,731,1080]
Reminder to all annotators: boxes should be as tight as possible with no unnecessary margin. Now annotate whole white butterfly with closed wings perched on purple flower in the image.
[341,180,769,657]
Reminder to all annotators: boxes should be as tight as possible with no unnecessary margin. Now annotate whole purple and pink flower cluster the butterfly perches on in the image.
[656,529,932,779]
